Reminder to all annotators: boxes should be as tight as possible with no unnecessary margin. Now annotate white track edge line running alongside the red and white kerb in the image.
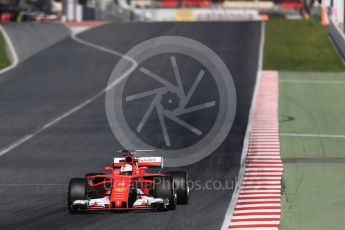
[221,22,265,230]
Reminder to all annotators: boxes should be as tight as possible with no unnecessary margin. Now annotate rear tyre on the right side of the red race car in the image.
[168,171,189,204]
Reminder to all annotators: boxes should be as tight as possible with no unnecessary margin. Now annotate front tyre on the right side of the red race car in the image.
[154,176,177,210]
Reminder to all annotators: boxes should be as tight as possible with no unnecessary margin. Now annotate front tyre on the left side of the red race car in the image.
[68,178,87,214]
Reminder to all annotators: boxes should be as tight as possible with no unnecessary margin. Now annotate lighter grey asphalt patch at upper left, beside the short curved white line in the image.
[4,22,70,62]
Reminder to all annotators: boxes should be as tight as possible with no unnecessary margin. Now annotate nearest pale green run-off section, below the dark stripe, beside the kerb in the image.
[279,163,345,230]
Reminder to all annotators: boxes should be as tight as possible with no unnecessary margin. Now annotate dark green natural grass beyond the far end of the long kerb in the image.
[264,19,345,72]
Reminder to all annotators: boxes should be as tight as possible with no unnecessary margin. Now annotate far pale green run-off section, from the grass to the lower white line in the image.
[279,72,345,134]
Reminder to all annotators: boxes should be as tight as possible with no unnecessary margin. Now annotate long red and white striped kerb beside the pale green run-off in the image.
[229,71,283,230]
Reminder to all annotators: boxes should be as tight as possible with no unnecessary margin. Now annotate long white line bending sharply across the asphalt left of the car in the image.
[0,25,137,156]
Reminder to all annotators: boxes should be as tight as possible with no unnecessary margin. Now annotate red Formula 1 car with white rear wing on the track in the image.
[68,150,189,213]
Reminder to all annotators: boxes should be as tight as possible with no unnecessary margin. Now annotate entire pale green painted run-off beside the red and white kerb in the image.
[279,72,345,230]
